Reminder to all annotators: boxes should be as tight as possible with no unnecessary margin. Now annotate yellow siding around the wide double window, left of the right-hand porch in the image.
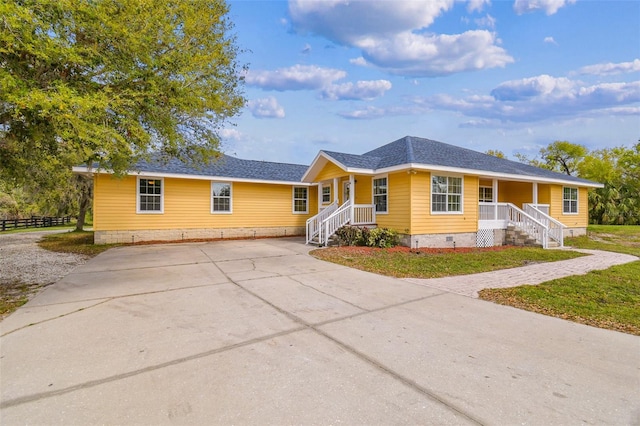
[408,173,479,234]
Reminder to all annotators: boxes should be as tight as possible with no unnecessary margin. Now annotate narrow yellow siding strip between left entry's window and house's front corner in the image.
[376,171,411,232]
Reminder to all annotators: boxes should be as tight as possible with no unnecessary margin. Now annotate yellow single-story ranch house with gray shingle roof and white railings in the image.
[74,136,602,248]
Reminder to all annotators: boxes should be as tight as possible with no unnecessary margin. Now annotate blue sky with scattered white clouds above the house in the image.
[221,0,640,164]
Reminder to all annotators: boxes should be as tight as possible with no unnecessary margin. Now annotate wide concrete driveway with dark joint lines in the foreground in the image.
[0,239,640,425]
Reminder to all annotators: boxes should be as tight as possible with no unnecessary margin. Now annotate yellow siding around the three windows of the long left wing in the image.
[94,174,318,231]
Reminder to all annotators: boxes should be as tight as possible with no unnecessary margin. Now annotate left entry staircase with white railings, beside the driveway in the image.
[306,201,376,246]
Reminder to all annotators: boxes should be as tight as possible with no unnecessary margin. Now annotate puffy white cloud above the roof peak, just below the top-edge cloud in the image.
[361,30,513,77]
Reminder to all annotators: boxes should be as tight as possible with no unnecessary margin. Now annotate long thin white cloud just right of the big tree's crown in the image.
[245,65,347,91]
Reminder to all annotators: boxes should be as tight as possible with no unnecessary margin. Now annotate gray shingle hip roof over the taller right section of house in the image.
[323,136,593,183]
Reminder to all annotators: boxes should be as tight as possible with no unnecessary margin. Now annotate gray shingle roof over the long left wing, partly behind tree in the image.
[134,154,307,182]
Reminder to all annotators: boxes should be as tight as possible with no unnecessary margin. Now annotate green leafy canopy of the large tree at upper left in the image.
[0,0,244,186]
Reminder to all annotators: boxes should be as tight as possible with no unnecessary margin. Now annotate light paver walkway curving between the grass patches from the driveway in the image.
[404,249,640,298]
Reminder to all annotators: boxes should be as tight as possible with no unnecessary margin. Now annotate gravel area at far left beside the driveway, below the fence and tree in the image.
[0,230,89,286]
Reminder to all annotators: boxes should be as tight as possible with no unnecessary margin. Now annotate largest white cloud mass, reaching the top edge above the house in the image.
[289,0,513,77]
